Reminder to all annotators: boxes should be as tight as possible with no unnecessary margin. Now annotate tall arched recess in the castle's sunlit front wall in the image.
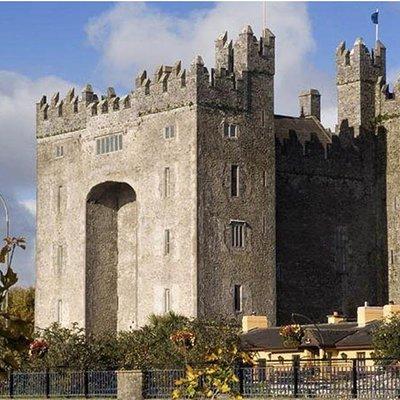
[86,182,137,335]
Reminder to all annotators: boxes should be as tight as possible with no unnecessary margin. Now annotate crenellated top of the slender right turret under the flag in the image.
[336,38,386,85]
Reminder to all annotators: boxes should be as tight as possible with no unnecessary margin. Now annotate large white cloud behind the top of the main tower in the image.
[86,2,335,126]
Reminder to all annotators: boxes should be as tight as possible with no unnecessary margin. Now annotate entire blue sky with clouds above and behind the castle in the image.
[0,2,400,285]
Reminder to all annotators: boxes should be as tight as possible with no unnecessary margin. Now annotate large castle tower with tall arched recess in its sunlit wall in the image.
[35,27,276,333]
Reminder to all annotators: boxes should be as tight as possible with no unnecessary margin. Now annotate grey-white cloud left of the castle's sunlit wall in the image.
[0,71,70,285]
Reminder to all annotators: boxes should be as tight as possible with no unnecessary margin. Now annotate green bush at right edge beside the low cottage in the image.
[372,314,400,364]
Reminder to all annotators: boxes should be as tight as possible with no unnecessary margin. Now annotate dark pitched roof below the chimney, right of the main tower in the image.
[275,115,332,147]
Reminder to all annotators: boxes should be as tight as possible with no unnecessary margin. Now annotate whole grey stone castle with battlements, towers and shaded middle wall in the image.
[36,26,400,333]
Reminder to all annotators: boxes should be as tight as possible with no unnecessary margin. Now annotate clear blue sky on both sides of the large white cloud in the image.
[0,2,400,89]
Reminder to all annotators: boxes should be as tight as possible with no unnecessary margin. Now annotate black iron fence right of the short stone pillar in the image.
[143,360,400,400]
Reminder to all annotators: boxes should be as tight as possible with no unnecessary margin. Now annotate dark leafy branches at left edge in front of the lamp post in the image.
[0,237,30,375]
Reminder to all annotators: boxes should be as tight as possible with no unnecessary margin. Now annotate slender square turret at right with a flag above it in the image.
[336,38,386,136]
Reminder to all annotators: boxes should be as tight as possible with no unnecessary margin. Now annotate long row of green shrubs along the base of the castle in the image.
[24,313,244,370]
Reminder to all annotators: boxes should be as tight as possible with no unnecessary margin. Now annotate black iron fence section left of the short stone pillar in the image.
[0,371,117,398]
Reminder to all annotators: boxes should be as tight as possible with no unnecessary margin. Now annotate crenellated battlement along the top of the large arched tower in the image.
[36,26,275,137]
